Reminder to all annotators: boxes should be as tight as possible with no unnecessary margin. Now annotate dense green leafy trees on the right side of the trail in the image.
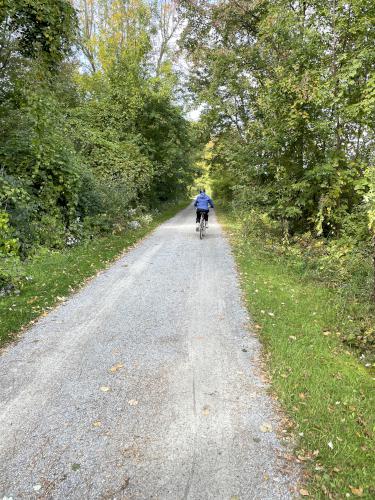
[181,0,375,290]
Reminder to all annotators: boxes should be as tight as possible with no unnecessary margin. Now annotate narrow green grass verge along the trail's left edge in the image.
[0,201,188,345]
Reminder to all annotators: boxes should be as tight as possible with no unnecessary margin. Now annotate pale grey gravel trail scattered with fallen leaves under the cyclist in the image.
[0,206,297,500]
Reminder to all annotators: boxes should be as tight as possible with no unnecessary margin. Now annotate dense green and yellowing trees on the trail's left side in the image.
[0,0,193,291]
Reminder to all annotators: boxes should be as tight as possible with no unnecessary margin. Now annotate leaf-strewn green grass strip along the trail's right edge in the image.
[219,213,375,498]
